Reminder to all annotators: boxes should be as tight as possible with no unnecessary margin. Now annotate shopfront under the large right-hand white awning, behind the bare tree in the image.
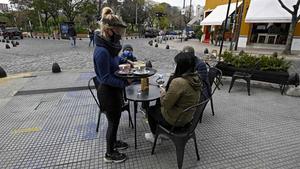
[245,0,300,50]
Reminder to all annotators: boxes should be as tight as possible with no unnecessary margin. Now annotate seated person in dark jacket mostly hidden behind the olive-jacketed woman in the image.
[182,46,211,100]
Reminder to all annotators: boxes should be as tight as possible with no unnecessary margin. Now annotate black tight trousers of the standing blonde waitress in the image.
[97,85,123,154]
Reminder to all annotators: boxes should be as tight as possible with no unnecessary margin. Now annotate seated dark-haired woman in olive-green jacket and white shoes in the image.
[145,52,202,143]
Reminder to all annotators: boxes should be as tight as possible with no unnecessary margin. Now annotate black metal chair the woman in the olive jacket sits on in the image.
[151,99,209,169]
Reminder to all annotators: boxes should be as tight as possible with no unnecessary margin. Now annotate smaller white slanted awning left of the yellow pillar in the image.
[200,2,242,25]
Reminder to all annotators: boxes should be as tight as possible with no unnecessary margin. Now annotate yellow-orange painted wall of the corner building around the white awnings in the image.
[205,0,300,36]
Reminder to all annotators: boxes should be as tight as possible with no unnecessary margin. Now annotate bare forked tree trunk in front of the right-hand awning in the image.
[278,0,300,54]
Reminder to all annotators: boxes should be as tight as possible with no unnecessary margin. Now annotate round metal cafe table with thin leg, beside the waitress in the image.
[125,84,160,148]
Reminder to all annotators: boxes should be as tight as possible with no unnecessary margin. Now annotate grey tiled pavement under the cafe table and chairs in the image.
[0,73,300,169]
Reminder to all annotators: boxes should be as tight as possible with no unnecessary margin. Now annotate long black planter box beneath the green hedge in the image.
[216,62,290,86]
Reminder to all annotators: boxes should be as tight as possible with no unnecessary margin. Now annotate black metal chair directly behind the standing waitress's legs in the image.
[88,76,133,132]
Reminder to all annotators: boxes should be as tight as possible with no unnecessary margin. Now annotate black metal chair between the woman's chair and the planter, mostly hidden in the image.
[206,67,222,118]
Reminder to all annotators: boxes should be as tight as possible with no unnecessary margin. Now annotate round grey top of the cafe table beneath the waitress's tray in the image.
[125,84,160,102]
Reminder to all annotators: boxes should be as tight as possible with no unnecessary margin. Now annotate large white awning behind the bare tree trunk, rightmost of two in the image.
[246,0,300,23]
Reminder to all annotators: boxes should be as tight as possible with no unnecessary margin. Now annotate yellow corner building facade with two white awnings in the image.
[201,0,300,50]
